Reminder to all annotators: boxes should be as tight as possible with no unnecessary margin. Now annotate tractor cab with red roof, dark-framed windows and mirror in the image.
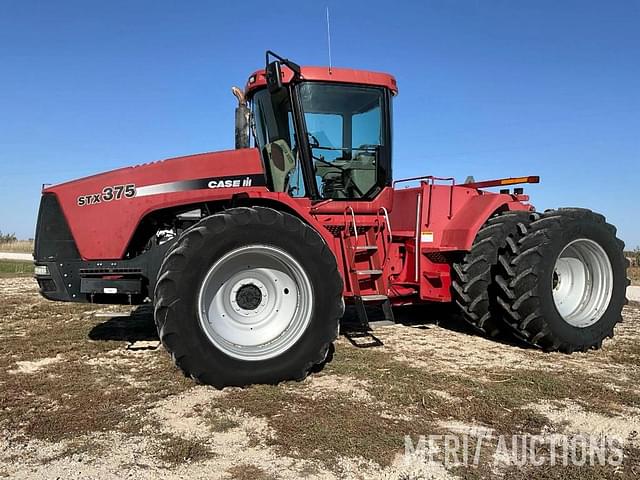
[242,52,397,200]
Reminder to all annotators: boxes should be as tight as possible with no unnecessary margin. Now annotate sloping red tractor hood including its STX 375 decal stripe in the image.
[36,148,267,259]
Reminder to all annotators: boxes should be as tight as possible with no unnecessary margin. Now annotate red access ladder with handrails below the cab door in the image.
[342,206,395,338]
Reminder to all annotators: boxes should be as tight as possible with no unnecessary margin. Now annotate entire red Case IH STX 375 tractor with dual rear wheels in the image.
[35,52,628,387]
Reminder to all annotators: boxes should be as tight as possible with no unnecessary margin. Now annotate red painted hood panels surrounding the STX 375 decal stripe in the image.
[44,149,267,260]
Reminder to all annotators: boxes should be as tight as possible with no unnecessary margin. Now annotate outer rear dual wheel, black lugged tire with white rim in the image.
[496,208,628,353]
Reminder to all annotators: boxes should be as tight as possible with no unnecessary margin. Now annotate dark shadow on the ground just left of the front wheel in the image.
[88,305,159,345]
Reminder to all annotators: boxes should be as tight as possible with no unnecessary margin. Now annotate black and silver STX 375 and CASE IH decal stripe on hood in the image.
[77,173,267,207]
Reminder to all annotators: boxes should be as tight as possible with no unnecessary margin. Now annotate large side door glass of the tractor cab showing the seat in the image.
[300,82,384,199]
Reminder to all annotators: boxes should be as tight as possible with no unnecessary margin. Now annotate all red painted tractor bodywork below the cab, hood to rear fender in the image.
[45,149,532,304]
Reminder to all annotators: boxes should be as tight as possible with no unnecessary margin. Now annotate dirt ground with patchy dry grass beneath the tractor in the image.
[0,278,640,480]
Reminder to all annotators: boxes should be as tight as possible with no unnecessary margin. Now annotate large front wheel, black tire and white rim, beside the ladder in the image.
[155,207,344,388]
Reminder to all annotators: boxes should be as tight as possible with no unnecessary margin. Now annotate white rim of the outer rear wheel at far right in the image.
[552,238,613,328]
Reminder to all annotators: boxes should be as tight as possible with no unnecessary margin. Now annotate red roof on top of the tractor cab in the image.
[245,65,398,96]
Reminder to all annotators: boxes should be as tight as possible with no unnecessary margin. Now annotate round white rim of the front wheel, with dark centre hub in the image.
[198,245,313,360]
